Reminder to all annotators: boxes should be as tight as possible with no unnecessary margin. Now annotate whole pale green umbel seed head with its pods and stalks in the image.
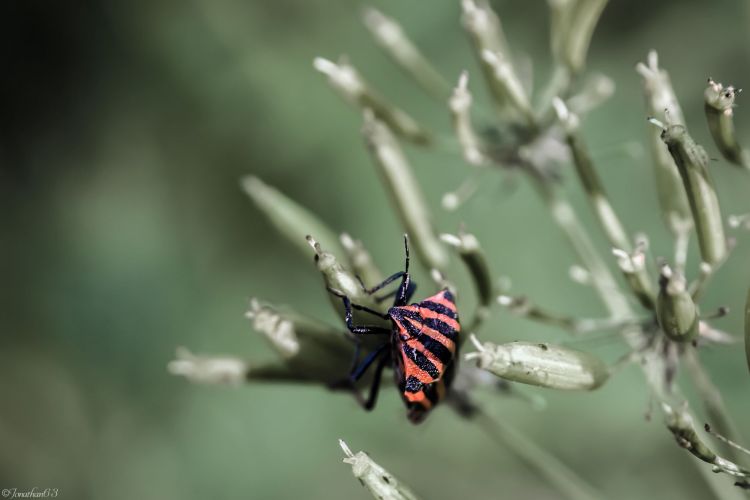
[169,0,750,499]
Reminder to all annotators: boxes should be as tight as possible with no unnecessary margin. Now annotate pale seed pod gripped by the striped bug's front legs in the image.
[307,236,389,326]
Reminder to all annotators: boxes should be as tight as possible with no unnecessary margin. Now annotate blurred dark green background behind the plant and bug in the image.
[0,0,750,500]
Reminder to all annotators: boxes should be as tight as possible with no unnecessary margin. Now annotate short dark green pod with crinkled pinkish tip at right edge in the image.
[703,78,750,169]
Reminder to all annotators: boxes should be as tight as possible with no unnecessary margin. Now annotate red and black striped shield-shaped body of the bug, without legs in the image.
[388,289,461,423]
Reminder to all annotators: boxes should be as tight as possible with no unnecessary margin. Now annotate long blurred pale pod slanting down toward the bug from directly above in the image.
[362,112,448,271]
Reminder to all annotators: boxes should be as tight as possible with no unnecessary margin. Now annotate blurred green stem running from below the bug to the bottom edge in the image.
[474,410,606,500]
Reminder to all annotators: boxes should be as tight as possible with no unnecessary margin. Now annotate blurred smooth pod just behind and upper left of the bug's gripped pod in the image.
[241,175,344,256]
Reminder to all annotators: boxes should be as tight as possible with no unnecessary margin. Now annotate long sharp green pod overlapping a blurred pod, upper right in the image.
[661,124,727,265]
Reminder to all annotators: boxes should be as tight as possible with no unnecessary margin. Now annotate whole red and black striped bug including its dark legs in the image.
[330,236,461,424]
